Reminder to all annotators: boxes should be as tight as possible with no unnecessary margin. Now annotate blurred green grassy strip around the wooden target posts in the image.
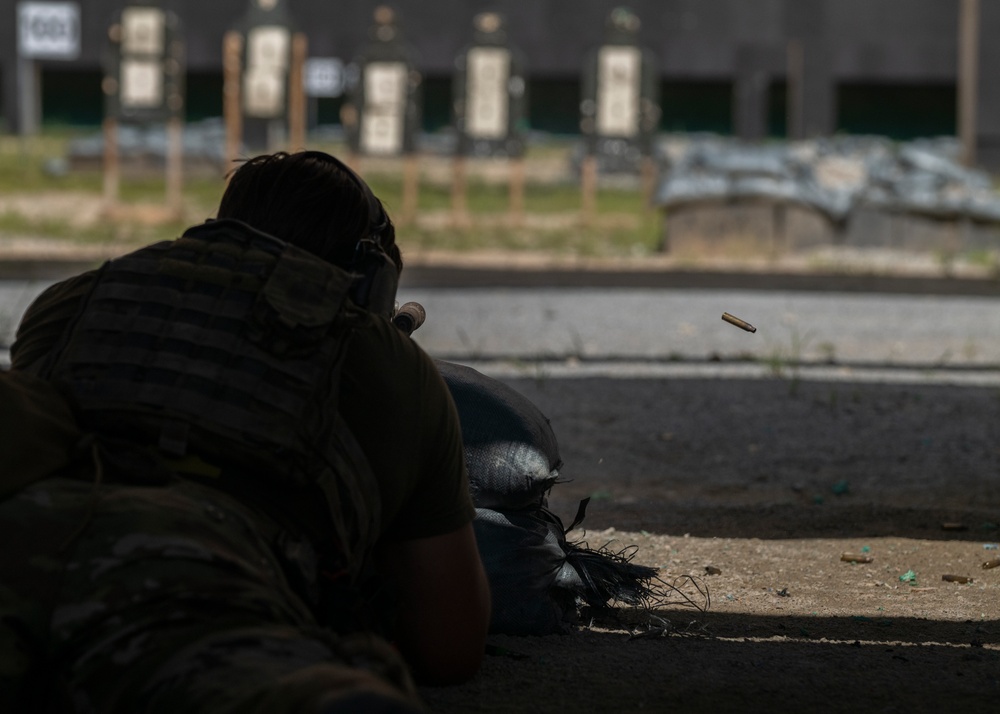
[0,128,661,257]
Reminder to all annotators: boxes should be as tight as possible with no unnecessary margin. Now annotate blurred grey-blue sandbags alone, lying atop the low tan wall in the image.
[657,137,1000,222]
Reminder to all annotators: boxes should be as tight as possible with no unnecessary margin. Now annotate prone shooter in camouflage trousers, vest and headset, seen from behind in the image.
[0,151,490,713]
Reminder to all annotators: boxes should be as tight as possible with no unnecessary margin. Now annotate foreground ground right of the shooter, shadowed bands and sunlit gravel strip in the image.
[423,378,1000,714]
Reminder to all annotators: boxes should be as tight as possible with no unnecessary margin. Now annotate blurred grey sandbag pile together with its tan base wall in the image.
[655,136,1000,253]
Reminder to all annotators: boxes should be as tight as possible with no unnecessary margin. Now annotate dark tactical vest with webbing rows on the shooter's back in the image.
[43,220,380,575]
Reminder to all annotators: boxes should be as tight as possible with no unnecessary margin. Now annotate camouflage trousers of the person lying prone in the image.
[0,474,419,714]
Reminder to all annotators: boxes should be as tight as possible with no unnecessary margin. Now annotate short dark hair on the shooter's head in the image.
[216,151,403,270]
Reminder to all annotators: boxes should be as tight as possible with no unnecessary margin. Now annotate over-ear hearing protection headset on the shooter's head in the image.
[305,151,399,318]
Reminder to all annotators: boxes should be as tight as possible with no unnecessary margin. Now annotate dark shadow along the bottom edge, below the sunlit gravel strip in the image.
[424,611,1000,713]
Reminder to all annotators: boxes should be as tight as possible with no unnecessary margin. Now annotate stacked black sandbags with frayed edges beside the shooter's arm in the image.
[438,362,656,635]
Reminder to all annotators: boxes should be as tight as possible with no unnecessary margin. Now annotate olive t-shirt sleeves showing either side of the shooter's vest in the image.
[11,272,475,541]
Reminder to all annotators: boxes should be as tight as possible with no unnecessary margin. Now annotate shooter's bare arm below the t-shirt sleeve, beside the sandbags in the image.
[379,524,490,684]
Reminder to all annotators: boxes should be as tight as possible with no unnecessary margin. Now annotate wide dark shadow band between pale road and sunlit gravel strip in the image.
[504,378,1000,540]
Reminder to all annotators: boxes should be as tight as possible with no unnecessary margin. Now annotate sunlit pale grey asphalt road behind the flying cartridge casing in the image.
[0,279,1000,379]
